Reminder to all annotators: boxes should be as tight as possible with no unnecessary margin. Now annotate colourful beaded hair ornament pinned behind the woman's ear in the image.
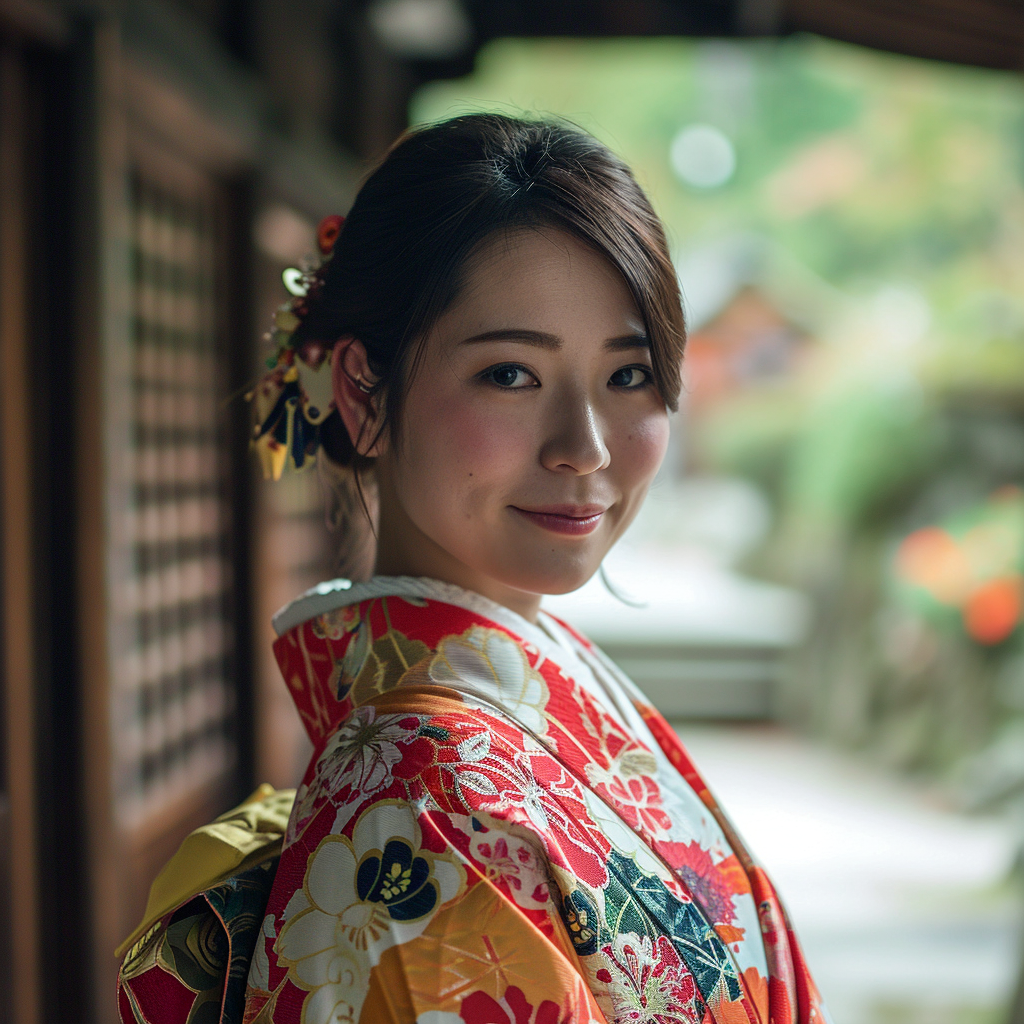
[246,214,345,480]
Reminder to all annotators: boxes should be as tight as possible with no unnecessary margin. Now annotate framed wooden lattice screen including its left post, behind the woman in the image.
[76,39,254,1024]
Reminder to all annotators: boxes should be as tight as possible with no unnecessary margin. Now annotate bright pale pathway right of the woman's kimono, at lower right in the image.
[679,724,1024,1024]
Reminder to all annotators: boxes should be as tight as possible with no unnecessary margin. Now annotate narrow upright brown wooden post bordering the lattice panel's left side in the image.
[74,22,130,1024]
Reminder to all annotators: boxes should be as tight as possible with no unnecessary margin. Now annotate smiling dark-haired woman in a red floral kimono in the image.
[120,115,824,1024]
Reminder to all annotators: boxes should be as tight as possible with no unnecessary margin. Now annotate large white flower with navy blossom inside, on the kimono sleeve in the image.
[274,801,465,1024]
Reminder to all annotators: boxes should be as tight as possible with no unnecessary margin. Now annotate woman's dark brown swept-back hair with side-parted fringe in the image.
[295,114,686,471]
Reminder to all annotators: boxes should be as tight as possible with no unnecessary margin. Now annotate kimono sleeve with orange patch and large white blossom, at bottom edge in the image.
[245,800,604,1024]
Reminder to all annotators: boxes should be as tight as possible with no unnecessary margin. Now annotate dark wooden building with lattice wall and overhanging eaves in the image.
[0,0,1024,1024]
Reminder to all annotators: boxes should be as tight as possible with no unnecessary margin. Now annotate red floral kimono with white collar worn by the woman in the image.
[119,577,828,1024]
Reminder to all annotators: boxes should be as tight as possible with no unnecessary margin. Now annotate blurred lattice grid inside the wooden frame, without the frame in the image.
[115,170,236,817]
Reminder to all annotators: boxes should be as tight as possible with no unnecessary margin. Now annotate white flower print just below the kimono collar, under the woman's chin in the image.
[430,626,549,735]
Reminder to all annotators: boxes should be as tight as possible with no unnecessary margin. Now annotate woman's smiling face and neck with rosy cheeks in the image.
[377,228,669,617]
